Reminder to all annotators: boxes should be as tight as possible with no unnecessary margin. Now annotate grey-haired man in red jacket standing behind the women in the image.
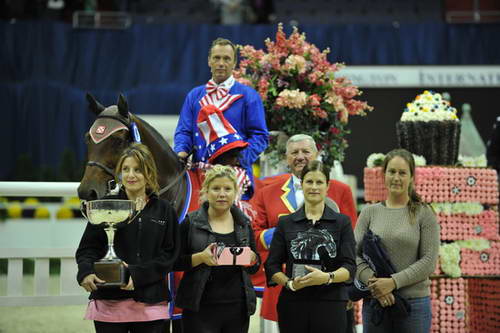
[251,134,357,326]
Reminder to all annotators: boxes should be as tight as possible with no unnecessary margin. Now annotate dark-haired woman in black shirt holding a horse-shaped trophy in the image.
[265,161,356,333]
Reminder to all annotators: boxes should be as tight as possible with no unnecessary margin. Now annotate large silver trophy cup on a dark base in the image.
[81,199,138,287]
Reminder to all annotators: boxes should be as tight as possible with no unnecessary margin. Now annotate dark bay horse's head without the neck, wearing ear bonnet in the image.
[78,94,131,200]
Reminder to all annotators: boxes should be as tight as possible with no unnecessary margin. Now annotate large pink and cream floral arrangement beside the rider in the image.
[234,24,373,166]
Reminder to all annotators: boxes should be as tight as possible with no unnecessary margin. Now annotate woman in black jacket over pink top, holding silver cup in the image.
[76,143,180,333]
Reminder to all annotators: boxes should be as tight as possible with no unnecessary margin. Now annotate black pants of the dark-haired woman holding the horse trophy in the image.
[277,297,347,333]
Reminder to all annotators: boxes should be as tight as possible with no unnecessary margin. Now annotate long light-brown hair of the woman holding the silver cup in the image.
[115,143,160,194]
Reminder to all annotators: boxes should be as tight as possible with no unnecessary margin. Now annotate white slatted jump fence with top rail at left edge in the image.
[0,182,88,306]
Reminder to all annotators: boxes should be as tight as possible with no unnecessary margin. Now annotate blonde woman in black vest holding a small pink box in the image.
[175,165,260,333]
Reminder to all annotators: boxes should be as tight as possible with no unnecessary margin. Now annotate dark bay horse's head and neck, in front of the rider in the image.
[78,94,190,216]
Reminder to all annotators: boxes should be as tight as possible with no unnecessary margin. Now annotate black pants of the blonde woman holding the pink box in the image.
[182,302,250,333]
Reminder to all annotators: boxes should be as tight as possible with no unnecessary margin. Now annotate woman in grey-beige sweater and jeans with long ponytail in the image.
[354,149,440,333]
